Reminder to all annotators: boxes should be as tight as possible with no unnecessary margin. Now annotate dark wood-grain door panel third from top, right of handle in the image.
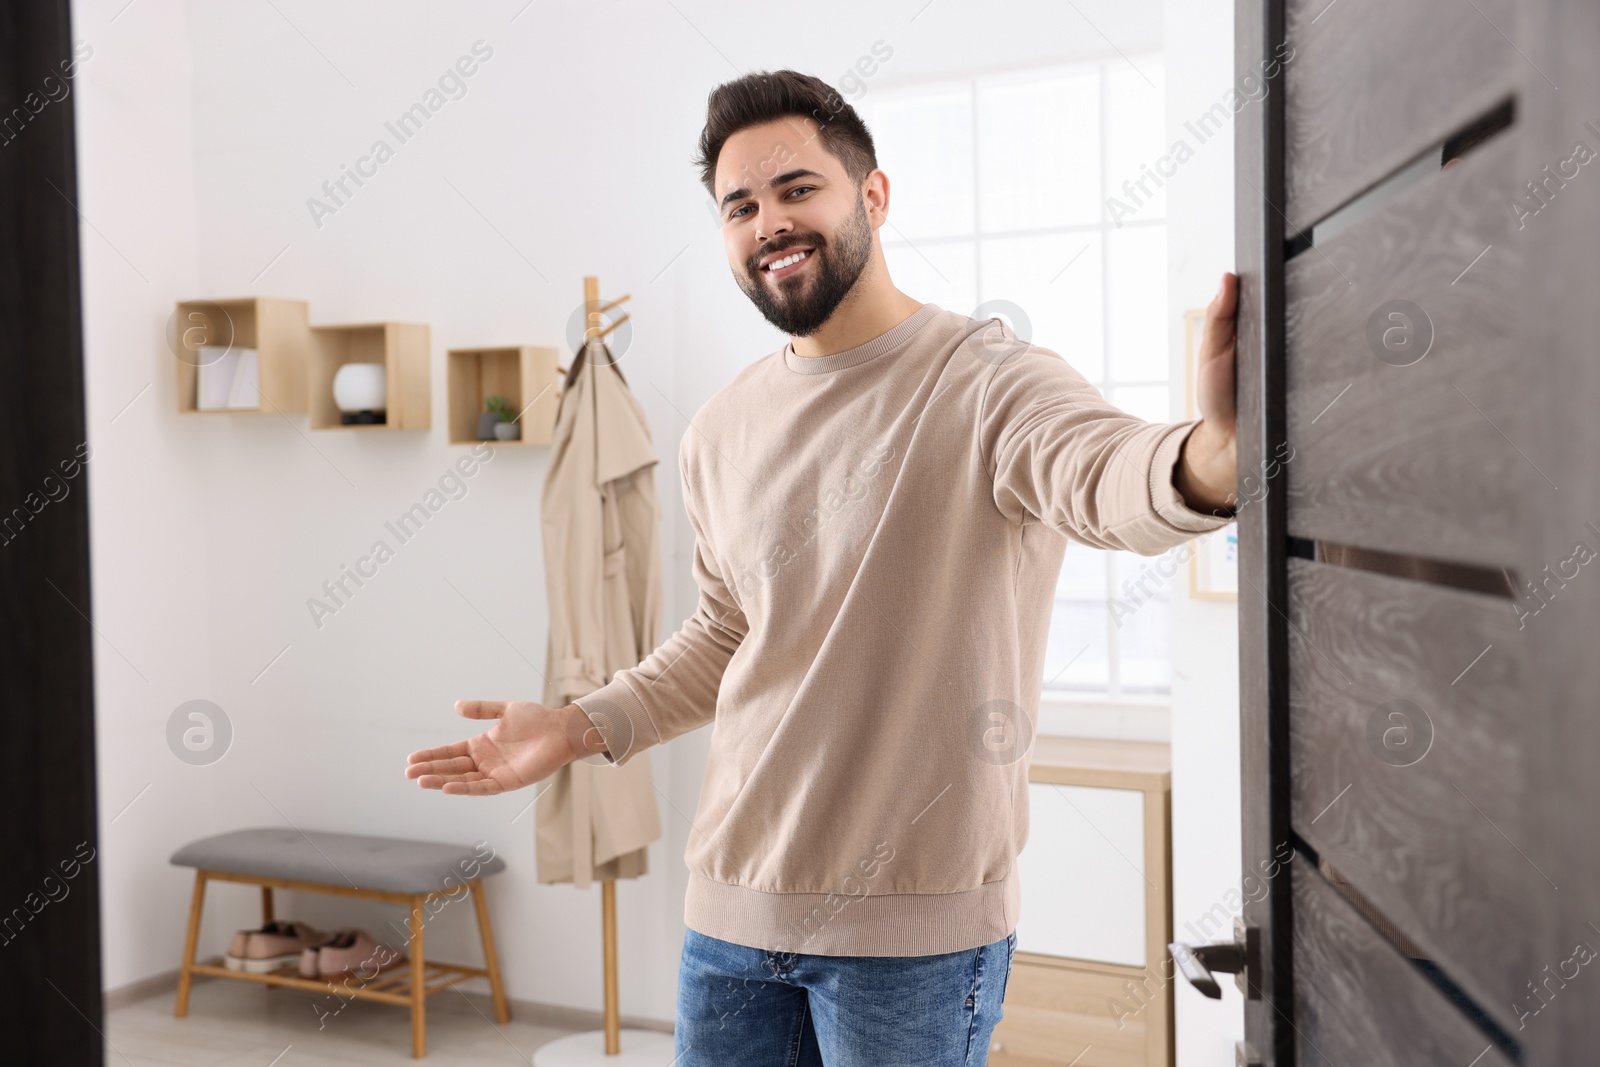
[1288,558,1536,1029]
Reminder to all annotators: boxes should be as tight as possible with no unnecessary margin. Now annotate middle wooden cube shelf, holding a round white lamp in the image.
[310,322,432,430]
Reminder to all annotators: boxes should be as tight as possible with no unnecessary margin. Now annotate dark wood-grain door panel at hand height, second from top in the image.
[1285,128,1529,568]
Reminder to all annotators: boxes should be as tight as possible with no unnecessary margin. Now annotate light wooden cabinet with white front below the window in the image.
[989,736,1174,1067]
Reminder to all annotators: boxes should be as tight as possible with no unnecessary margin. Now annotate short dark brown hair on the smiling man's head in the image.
[694,70,878,200]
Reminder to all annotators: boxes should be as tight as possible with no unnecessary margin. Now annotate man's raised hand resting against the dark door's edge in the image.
[1173,270,1238,514]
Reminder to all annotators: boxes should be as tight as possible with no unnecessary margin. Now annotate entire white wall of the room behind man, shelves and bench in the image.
[74,0,1260,1036]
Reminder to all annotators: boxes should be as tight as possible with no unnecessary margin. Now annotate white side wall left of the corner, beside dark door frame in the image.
[69,3,216,1004]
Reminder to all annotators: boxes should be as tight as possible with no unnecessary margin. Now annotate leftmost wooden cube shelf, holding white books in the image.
[173,296,310,414]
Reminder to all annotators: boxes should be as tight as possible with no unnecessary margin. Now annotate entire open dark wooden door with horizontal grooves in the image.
[1216,0,1600,1067]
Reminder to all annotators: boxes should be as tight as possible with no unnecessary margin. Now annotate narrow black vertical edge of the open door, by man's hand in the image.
[1234,0,1294,1067]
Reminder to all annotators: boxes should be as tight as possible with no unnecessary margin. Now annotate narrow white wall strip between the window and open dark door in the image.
[1165,0,1254,1067]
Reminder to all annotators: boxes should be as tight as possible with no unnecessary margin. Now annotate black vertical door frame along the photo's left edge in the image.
[0,0,104,1065]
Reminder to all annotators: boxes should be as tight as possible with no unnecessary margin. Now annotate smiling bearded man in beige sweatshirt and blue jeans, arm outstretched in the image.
[406,70,1237,1067]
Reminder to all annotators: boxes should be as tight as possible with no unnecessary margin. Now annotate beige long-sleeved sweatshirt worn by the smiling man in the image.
[576,304,1229,955]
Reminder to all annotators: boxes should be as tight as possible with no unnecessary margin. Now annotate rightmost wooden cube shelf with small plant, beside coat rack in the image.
[445,344,562,445]
